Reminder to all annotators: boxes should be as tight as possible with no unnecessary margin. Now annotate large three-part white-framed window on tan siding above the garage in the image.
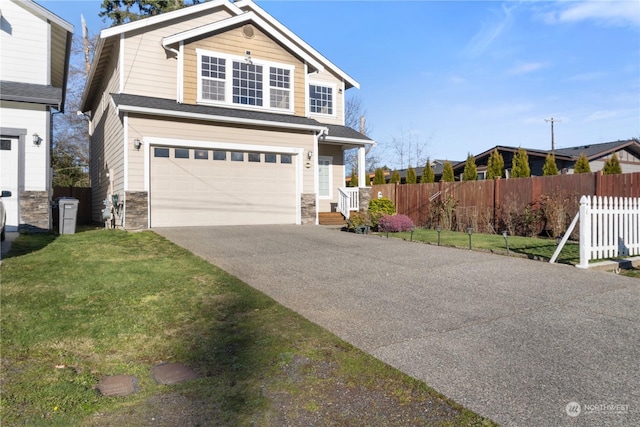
[197,49,294,112]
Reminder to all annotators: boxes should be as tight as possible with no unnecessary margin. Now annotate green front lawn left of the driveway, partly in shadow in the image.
[0,230,493,426]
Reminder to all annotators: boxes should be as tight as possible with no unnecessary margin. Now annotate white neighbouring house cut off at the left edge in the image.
[0,0,73,231]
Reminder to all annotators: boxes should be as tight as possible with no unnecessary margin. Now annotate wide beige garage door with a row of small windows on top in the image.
[149,147,296,227]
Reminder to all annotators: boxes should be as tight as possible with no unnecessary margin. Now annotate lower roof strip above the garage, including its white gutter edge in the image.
[111,93,375,145]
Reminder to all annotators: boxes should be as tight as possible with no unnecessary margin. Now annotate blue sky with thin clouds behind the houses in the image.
[38,0,640,167]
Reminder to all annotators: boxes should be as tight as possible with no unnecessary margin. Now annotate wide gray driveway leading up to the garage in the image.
[154,226,640,426]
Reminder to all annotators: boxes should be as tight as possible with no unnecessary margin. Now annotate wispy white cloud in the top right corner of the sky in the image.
[546,0,640,26]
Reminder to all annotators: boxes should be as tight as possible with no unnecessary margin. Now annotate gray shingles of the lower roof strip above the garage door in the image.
[111,93,373,142]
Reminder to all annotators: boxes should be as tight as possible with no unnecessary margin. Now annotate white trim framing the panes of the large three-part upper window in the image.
[196,49,295,114]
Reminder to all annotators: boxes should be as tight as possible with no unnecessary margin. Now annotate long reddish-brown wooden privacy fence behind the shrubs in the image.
[372,172,640,233]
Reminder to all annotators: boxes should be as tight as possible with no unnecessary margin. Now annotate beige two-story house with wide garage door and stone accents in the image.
[82,0,374,229]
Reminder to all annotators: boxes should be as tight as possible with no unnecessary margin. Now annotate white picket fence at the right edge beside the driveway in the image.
[578,196,640,268]
